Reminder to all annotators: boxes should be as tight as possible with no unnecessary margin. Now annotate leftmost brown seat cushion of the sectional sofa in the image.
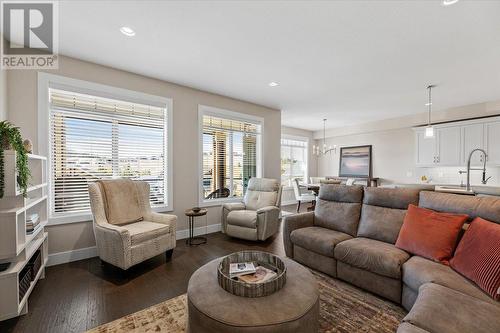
[290,227,352,258]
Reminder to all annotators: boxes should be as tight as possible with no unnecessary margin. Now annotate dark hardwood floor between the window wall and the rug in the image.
[0,206,306,333]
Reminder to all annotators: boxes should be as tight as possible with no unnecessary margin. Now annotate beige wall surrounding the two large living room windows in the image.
[8,57,281,253]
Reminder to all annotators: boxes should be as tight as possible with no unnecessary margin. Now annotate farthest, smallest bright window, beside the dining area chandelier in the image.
[281,136,308,186]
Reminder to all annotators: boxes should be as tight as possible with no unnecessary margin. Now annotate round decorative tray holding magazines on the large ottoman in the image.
[217,251,286,297]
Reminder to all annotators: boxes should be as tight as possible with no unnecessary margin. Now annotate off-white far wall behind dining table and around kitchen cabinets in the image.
[314,101,500,185]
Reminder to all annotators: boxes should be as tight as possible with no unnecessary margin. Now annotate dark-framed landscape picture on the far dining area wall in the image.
[339,145,372,178]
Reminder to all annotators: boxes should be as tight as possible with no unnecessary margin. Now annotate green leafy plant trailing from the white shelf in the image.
[0,121,31,198]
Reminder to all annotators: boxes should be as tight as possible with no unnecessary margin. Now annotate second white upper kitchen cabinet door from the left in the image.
[435,126,461,166]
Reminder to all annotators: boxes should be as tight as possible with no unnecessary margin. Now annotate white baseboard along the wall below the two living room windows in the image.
[47,223,221,266]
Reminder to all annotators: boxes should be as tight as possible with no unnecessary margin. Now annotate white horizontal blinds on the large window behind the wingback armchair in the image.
[49,89,167,216]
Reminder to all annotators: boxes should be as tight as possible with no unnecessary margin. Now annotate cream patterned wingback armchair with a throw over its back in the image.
[89,179,177,269]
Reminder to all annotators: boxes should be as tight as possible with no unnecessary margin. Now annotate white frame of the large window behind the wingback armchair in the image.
[38,72,174,225]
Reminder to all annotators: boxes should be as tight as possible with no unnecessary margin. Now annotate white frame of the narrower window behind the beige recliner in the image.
[198,104,264,207]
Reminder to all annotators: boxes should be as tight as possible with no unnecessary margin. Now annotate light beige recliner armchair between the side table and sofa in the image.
[222,178,281,240]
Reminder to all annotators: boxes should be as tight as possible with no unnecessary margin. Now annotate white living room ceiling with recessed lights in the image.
[55,0,500,130]
